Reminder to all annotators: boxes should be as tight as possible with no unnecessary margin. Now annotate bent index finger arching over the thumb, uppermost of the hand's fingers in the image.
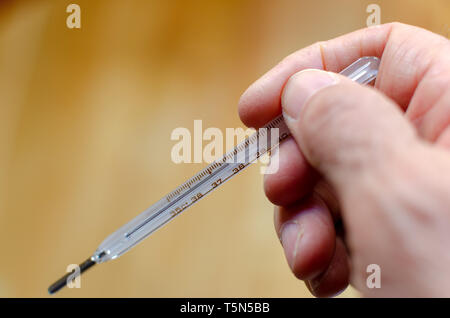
[239,23,450,128]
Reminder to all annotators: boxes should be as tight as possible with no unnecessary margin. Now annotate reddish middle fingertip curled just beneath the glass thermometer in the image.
[264,138,318,206]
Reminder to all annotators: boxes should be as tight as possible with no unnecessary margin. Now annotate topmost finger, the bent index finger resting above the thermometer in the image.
[239,23,450,141]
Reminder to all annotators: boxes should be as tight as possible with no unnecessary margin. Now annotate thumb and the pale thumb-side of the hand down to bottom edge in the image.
[282,71,450,296]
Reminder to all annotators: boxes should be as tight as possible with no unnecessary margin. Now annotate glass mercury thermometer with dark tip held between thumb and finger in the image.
[48,56,380,294]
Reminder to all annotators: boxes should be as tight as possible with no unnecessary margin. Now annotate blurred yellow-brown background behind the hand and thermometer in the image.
[0,0,450,297]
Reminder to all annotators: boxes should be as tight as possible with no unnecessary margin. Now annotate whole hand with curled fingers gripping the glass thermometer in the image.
[239,23,450,297]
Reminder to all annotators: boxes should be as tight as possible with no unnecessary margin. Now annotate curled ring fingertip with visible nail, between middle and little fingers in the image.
[275,197,335,279]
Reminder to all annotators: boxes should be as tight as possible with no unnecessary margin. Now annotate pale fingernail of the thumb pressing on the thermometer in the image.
[281,69,338,120]
